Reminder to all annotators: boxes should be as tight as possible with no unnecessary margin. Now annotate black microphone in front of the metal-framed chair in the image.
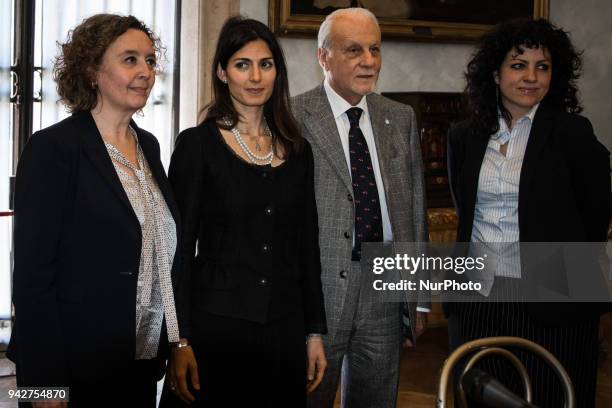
[461,368,537,408]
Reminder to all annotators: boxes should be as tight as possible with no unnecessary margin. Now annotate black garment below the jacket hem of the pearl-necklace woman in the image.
[160,311,306,408]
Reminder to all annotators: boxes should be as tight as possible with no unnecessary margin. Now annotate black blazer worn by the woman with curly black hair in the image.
[447,104,610,323]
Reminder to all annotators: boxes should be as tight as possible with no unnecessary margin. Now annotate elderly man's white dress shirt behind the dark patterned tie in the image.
[323,79,393,242]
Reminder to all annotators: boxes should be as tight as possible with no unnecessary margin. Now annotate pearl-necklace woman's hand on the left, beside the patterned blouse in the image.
[166,346,200,404]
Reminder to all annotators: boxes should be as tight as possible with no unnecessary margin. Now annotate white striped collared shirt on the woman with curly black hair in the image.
[471,104,539,278]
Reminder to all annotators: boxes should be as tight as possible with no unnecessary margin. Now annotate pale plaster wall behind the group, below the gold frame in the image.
[240,0,612,150]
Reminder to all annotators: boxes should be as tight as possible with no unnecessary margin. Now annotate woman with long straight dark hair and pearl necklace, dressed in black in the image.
[163,17,326,407]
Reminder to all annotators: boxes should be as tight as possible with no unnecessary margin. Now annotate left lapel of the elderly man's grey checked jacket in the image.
[304,85,353,191]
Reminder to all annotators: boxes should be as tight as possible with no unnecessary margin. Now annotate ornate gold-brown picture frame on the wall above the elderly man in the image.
[268,0,549,42]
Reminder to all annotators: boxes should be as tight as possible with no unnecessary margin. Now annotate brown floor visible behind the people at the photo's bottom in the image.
[0,314,612,408]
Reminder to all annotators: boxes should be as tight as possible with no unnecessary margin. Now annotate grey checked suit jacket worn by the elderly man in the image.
[292,84,429,338]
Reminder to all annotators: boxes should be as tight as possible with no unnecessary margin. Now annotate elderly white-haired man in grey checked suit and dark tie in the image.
[293,8,428,408]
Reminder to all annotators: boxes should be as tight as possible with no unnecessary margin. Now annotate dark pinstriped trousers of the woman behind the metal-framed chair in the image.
[449,302,599,408]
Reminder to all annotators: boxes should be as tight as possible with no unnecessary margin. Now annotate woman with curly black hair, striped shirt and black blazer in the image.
[446,19,610,407]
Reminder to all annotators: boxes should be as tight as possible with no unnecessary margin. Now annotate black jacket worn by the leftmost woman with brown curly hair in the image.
[8,112,179,386]
